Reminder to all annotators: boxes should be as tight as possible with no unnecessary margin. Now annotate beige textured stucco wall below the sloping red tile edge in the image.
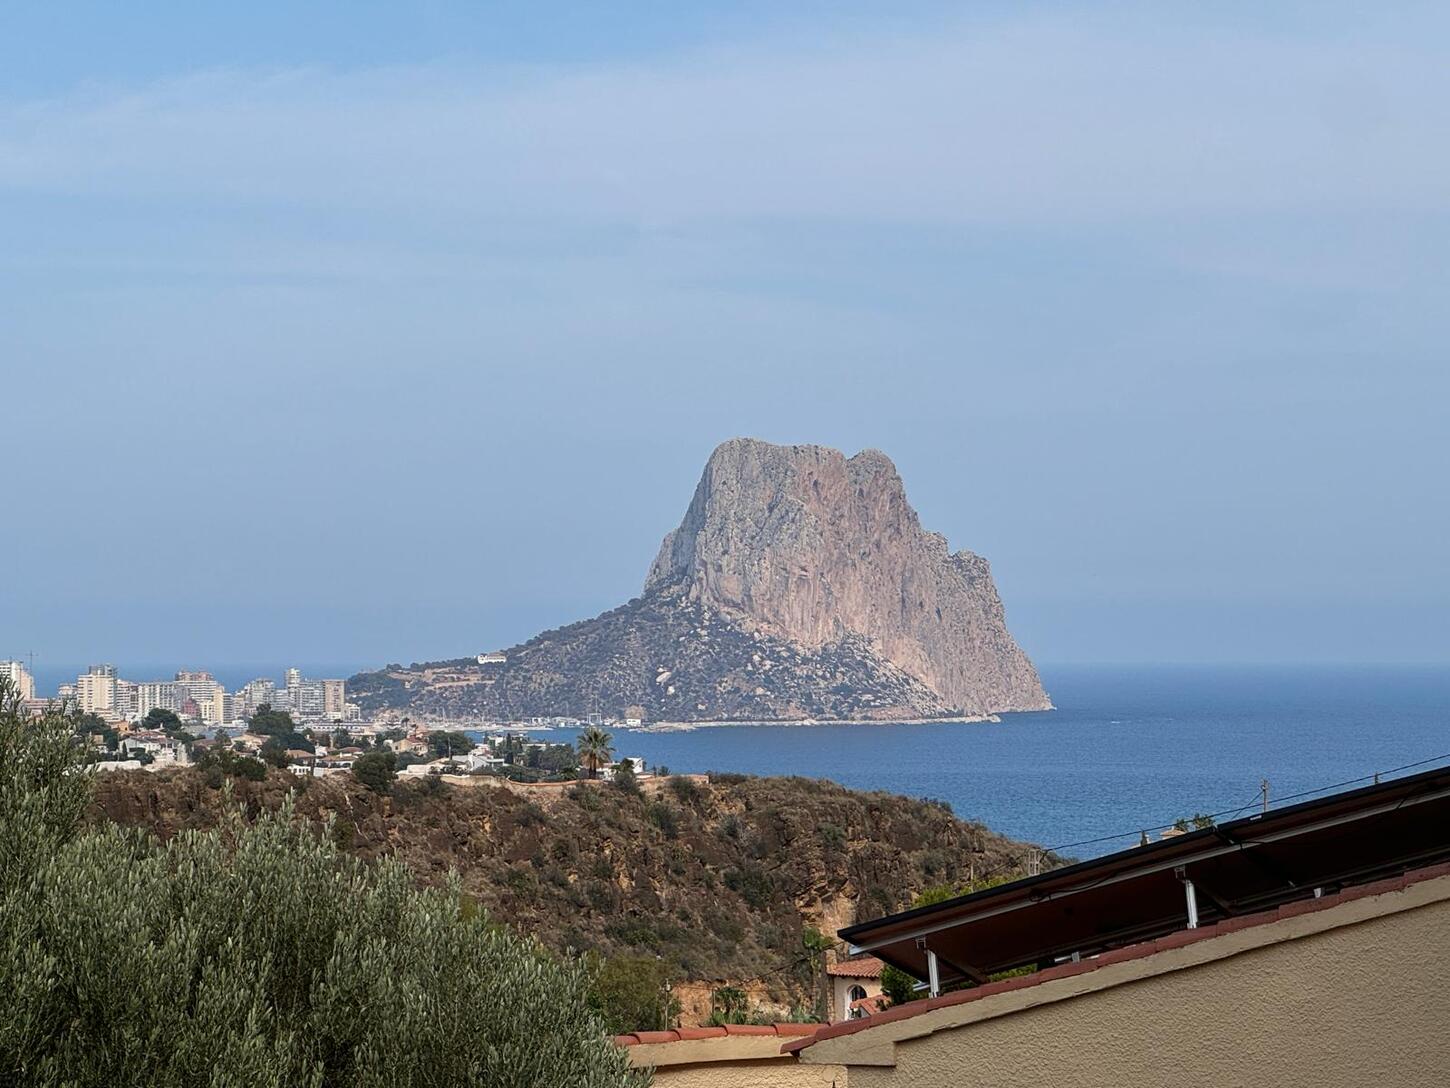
[841,878,1450,1088]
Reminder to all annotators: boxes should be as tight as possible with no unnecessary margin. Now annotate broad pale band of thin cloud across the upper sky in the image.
[11,10,1450,225]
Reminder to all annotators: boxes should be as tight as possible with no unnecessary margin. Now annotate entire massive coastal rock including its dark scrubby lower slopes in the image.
[352,438,1050,721]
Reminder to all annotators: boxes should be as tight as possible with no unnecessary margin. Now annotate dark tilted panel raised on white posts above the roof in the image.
[840,767,1450,984]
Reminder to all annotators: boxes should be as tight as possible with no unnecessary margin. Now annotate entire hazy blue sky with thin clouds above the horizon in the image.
[0,3,1450,666]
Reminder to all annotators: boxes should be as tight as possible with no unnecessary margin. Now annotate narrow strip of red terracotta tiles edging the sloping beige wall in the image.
[780,863,1450,1053]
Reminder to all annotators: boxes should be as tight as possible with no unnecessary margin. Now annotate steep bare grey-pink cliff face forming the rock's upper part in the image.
[645,438,1048,714]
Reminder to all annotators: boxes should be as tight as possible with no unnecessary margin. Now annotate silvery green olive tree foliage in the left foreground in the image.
[0,681,648,1088]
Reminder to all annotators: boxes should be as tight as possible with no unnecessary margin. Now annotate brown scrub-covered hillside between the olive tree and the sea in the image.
[93,770,1028,994]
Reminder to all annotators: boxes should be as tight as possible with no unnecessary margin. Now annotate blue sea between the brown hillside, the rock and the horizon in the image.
[516,667,1450,857]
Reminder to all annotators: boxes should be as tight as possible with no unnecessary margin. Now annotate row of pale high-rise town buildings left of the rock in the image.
[0,662,353,725]
